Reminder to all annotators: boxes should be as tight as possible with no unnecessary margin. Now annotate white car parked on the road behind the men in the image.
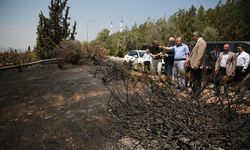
[124,50,146,71]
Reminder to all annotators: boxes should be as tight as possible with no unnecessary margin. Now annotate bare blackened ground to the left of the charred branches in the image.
[0,65,111,150]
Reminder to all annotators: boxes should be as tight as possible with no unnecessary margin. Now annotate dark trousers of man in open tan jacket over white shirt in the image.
[215,67,230,96]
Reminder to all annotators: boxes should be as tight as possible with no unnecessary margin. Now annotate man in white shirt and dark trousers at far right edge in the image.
[234,44,250,82]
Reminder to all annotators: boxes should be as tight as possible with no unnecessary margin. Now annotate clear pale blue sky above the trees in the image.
[0,0,219,50]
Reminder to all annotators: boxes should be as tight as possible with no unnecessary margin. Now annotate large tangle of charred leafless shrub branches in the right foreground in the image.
[92,60,250,150]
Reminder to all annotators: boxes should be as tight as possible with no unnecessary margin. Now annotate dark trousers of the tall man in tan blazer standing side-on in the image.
[190,68,202,98]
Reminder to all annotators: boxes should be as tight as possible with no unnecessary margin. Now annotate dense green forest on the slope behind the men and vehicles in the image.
[96,0,250,56]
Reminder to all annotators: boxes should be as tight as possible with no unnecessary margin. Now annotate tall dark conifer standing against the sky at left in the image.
[35,0,76,59]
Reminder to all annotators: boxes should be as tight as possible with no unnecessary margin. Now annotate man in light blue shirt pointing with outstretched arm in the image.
[163,37,189,88]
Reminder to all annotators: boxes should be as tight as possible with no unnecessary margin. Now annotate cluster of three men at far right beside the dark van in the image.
[210,44,250,96]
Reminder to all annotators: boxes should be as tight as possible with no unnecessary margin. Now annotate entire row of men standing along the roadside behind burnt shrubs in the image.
[144,32,249,97]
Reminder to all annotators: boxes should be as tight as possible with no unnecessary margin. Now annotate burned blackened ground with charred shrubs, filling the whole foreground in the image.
[0,62,249,150]
